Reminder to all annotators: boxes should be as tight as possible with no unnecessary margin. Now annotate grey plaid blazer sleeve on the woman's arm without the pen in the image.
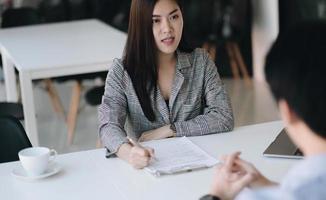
[174,50,234,136]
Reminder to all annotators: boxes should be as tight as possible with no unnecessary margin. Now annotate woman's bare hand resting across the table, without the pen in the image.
[138,125,174,142]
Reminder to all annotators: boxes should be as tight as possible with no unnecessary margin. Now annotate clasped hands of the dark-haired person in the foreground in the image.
[210,152,256,200]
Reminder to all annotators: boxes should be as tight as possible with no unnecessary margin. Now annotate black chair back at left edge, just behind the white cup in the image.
[0,116,32,163]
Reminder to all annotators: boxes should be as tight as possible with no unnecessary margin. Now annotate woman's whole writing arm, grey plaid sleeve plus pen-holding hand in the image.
[98,60,154,168]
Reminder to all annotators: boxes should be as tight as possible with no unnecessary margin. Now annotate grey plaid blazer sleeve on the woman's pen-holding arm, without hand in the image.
[98,60,128,152]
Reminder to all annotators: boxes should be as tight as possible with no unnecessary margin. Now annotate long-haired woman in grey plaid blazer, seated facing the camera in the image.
[99,0,233,168]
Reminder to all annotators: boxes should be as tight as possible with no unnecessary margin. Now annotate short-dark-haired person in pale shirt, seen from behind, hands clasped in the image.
[201,22,326,200]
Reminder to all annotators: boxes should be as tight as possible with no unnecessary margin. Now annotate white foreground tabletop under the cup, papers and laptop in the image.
[0,122,297,200]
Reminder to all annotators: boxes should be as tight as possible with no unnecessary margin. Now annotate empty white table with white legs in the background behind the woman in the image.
[0,19,127,146]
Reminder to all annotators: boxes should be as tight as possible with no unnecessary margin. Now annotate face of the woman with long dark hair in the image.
[152,0,183,54]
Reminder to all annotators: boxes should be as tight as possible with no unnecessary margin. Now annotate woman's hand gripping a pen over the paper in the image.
[128,146,154,169]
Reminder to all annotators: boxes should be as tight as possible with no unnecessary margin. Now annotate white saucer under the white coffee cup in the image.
[11,164,61,180]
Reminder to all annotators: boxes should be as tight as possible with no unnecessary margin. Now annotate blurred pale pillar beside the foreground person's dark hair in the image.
[251,0,279,81]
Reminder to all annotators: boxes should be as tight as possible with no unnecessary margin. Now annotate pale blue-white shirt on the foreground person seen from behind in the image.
[236,154,326,200]
